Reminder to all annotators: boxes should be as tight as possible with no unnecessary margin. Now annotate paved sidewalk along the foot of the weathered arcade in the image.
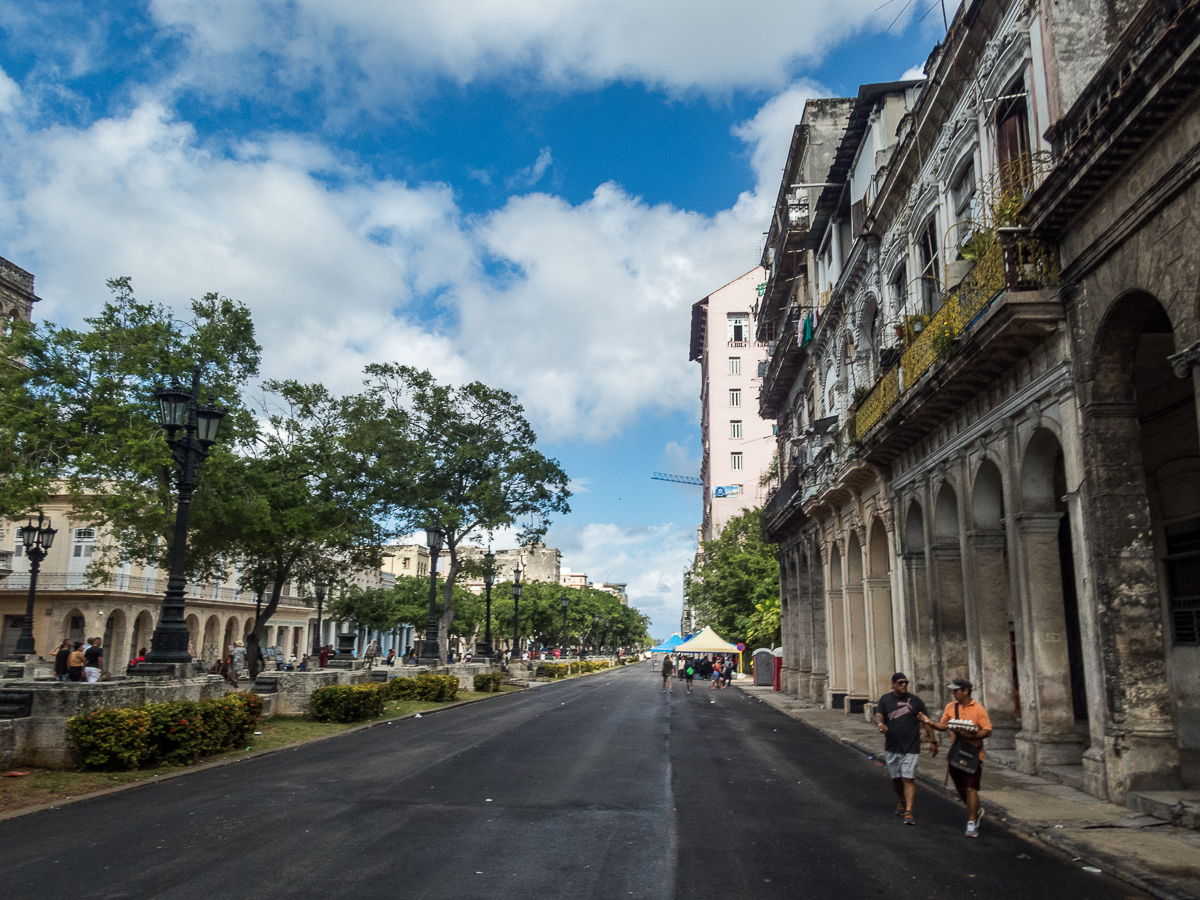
[734,679,1200,900]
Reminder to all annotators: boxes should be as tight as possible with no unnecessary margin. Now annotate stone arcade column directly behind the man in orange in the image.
[966,530,1016,750]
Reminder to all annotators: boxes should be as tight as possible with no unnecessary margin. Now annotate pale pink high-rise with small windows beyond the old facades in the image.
[689,266,775,540]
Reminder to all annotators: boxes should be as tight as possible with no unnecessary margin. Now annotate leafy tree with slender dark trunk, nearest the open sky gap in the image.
[354,365,570,662]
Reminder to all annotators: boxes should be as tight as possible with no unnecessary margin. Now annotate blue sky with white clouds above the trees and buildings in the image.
[0,0,940,637]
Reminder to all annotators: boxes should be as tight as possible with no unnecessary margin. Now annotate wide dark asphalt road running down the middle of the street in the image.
[0,665,1144,900]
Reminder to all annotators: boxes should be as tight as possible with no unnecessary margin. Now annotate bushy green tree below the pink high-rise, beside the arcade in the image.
[684,509,780,643]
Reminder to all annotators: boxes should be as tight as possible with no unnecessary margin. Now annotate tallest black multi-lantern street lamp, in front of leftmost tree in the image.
[138,366,226,674]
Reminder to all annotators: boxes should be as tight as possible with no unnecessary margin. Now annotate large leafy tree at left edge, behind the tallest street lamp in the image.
[0,277,260,578]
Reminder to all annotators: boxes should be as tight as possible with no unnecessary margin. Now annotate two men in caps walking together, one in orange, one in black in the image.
[875,672,991,838]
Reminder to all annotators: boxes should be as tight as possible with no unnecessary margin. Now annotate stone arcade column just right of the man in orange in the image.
[1016,512,1084,774]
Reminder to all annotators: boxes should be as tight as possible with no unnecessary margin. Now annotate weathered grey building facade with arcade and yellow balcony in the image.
[762,0,1200,802]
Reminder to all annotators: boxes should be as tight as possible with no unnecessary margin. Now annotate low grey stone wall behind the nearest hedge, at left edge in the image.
[0,676,228,769]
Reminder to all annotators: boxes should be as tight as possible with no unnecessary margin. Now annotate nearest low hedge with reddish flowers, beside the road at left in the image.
[67,694,263,769]
